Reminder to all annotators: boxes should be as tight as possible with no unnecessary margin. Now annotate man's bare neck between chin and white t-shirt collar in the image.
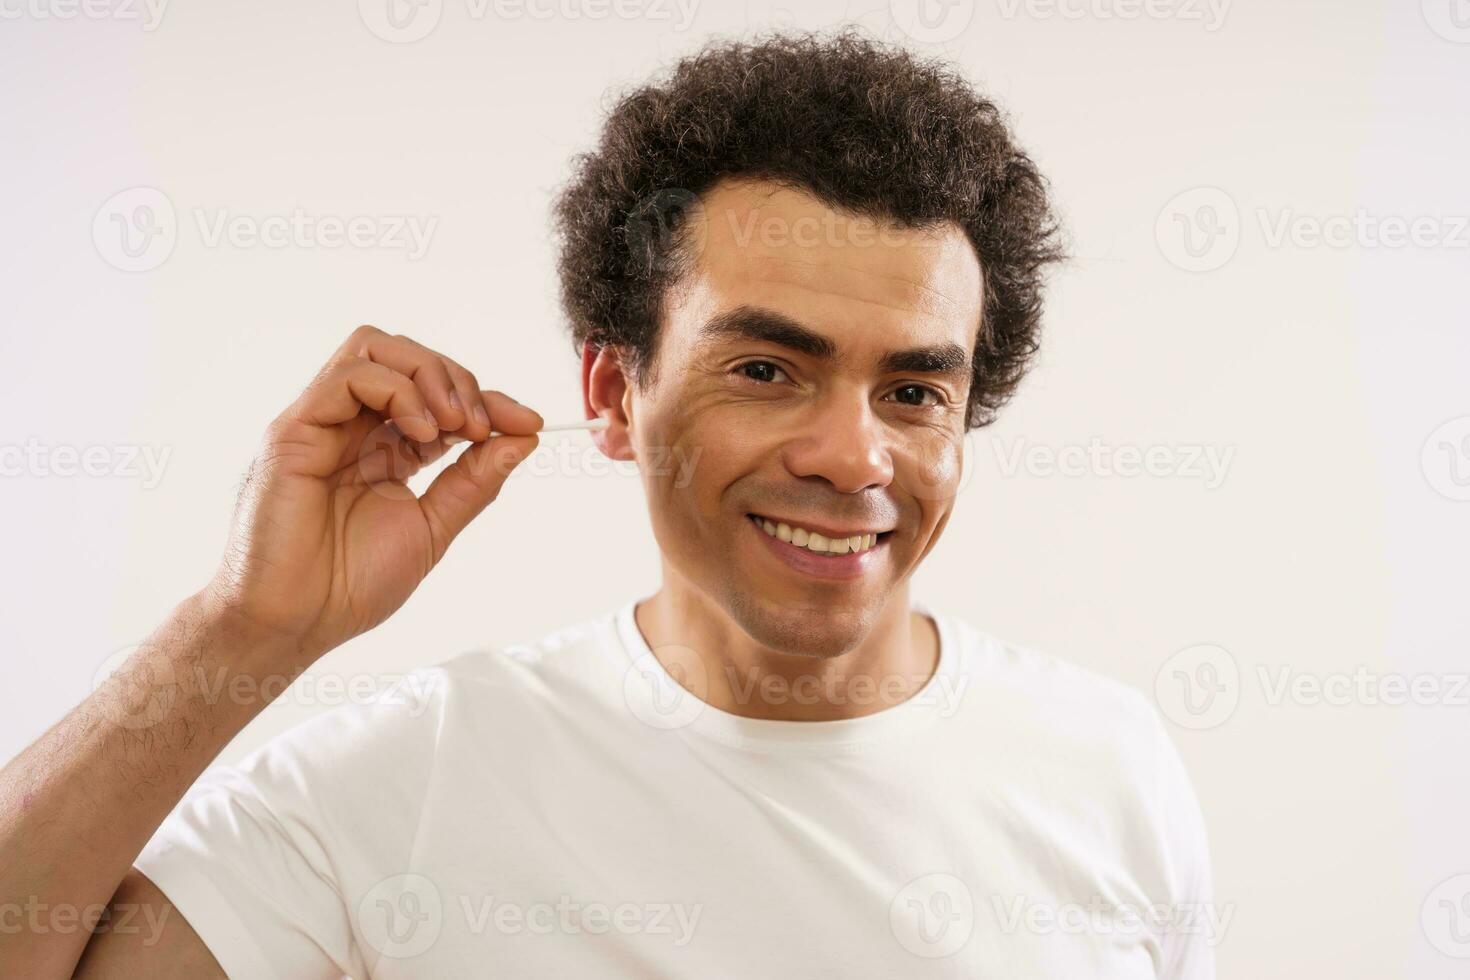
[634,566,939,721]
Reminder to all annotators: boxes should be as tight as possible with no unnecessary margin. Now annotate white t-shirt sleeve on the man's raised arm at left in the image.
[134,669,442,980]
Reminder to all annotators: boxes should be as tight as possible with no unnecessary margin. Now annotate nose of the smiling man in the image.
[782,391,894,494]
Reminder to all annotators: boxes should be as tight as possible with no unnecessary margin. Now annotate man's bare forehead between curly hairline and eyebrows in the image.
[675,181,983,350]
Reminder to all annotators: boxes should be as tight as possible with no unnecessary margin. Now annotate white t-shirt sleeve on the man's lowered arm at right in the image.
[1151,713,1229,980]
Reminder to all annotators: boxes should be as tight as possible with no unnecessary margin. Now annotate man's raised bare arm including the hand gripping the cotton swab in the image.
[0,328,542,979]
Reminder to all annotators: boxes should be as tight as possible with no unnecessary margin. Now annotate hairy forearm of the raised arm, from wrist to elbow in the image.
[0,594,305,977]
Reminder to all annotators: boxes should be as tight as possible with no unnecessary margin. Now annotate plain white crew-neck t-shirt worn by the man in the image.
[137,602,1227,980]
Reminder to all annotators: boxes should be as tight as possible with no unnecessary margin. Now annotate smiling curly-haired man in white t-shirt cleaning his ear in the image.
[0,26,1213,977]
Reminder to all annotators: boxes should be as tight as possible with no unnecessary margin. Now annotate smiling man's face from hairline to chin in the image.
[626,181,982,657]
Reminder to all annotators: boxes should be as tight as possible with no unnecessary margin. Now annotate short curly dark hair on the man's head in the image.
[554,28,1063,430]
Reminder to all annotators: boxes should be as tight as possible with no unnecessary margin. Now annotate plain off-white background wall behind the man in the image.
[0,0,1470,980]
